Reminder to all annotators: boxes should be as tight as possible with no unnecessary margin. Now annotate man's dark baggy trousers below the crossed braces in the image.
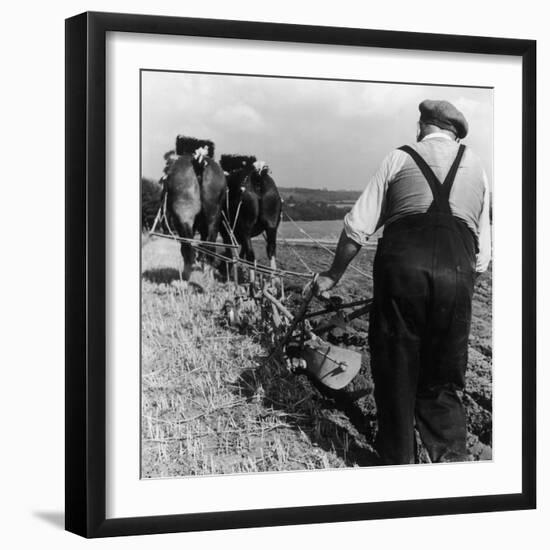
[369,214,475,464]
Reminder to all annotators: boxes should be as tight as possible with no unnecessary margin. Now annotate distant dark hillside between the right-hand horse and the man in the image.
[278,187,361,221]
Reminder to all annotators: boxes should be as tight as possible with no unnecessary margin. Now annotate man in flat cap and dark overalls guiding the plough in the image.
[314,100,491,464]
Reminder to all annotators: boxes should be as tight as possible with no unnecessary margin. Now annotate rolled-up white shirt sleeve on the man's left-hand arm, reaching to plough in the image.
[344,150,406,246]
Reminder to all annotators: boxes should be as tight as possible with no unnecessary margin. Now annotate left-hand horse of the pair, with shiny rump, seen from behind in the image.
[165,137,227,281]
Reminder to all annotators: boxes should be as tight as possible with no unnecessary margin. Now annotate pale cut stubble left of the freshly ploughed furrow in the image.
[142,239,380,477]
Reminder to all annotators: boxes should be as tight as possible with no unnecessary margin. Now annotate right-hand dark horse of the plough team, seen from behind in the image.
[220,155,282,282]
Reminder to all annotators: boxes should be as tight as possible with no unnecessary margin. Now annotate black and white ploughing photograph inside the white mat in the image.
[140,69,494,479]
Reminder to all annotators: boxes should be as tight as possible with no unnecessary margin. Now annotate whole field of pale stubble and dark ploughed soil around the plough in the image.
[142,226,492,478]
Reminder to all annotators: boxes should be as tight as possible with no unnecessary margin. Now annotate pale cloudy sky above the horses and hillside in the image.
[142,71,493,190]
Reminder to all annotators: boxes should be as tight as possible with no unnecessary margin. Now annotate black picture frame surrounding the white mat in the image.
[65,13,536,537]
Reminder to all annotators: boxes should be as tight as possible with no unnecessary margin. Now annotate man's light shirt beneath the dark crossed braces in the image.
[344,132,491,272]
